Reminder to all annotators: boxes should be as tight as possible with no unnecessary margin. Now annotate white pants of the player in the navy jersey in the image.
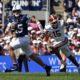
[10,36,33,56]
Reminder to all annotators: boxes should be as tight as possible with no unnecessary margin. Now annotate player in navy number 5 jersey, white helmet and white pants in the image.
[5,5,51,76]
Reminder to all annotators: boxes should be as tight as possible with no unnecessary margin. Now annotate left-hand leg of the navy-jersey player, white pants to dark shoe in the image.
[5,38,20,72]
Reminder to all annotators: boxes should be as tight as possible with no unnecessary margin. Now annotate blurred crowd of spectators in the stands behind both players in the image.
[0,0,80,55]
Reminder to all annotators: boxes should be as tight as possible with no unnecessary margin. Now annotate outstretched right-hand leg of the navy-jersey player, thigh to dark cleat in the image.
[21,36,51,76]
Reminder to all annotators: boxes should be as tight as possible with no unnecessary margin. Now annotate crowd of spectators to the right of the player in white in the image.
[63,0,80,54]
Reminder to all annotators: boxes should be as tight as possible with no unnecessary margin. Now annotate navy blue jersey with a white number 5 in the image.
[8,14,29,37]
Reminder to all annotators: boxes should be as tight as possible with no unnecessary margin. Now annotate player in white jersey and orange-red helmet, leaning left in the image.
[45,15,80,73]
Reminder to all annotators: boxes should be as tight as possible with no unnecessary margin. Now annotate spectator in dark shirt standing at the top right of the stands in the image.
[63,0,75,20]
